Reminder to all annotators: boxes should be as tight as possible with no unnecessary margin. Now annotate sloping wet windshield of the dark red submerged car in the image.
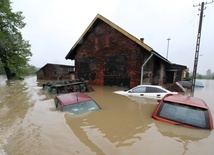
[62,100,100,114]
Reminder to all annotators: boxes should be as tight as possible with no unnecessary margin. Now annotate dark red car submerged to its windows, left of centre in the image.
[54,92,100,114]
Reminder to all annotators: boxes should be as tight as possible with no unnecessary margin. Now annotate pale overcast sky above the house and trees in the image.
[11,0,214,74]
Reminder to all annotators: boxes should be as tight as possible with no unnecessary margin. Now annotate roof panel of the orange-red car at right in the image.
[163,94,208,109]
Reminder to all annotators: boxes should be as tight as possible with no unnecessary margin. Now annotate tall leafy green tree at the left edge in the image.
[0,0,32,80]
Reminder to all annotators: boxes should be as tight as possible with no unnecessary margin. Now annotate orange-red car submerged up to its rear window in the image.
[152,94,213,130]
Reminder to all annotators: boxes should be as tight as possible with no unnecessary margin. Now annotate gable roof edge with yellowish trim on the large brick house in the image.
[65,14,152,60]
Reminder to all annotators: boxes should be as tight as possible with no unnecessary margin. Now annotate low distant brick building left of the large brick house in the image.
[36,63,75,80]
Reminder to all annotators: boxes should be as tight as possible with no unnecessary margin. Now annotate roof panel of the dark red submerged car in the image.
[56,92,92,106]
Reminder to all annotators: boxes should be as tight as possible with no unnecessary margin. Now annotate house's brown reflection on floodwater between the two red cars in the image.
[66,87,154,154]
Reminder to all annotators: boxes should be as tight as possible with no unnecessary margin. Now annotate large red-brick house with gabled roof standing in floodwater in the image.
[65,14,187,87]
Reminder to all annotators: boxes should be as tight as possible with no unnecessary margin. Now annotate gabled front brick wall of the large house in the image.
[75,21,150,87]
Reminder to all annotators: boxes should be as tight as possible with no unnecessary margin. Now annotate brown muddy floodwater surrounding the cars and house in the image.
[0,76,214,155]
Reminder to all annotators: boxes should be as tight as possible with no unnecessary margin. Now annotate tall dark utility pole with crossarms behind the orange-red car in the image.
[191,1,213,92]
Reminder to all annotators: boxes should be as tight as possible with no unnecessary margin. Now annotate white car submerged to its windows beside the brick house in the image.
[115,85,178,99]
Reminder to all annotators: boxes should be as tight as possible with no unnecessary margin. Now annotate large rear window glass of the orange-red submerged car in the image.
[157,102,210,129]
